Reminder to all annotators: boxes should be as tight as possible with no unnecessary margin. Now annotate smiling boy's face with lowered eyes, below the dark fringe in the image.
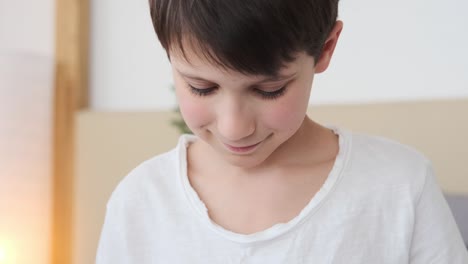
[171,50,315,168]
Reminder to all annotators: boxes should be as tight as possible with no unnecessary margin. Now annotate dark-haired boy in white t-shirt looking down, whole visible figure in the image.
[97,0,468,264]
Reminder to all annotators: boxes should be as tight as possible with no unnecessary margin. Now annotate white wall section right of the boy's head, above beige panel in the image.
[312,0,468,103]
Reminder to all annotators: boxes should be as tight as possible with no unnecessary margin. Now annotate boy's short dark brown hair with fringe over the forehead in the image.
[149,0,338,75]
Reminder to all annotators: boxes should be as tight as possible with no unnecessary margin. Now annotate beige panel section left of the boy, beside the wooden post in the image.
[73,112,178,264]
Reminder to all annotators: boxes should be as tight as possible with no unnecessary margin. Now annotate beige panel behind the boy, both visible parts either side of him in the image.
[74,99,468,264]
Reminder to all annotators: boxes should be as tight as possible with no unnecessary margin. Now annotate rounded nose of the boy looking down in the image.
[217,98,255,142]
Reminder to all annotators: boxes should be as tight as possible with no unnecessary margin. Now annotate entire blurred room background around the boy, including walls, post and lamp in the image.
[0,0,468,264]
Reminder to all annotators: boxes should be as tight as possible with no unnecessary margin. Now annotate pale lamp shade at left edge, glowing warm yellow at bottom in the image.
[0,54,55,264]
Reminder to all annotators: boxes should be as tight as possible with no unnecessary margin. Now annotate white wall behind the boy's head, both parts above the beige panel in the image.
[91,0,468,110]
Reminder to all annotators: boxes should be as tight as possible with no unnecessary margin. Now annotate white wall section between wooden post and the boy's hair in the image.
[90,0,174,110]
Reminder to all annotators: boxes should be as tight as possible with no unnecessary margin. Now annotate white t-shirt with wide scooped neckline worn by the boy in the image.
[96,129,468,264]
